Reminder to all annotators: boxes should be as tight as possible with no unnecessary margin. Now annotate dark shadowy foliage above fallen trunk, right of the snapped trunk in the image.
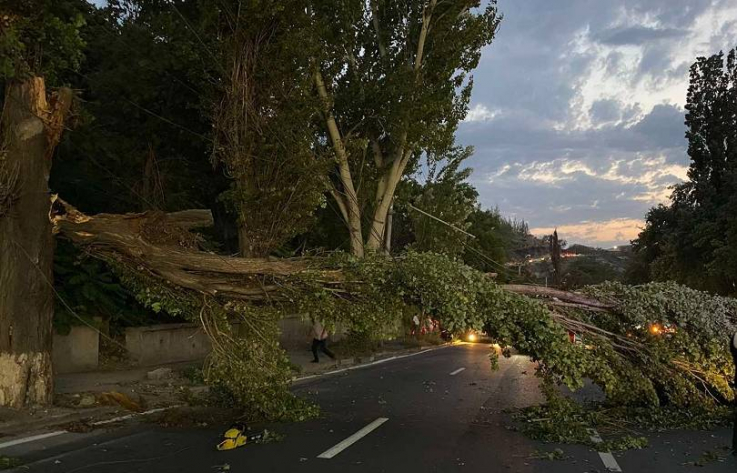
[50,0,214,213]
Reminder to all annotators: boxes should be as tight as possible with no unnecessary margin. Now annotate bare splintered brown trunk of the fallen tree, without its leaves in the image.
[52,199,339,301]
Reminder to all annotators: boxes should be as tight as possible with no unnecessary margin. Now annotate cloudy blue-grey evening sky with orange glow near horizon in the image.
[458,0,737,247]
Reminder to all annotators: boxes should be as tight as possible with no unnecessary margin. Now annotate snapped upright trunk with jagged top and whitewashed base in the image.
[0,77,72,409]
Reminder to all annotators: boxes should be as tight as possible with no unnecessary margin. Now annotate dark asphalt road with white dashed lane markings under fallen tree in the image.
[5,344,737,473]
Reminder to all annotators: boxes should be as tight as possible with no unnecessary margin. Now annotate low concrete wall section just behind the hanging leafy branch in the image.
[125,324,211,366]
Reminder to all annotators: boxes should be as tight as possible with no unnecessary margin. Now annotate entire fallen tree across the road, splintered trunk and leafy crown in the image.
[53,201,737,417]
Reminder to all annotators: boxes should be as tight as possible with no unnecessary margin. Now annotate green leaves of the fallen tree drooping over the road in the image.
[106,247,737,417]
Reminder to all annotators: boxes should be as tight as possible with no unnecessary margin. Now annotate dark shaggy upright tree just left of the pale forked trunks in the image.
[213,0,326,257]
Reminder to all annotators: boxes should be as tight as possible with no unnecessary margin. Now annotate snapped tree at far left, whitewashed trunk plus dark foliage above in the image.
[0,0,82,408]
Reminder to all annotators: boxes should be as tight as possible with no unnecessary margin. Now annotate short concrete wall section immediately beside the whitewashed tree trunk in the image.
[51,325,100,373]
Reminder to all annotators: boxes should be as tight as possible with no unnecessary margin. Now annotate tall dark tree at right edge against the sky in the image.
[629,49,737,294]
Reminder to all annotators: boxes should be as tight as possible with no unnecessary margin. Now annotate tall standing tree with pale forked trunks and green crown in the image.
[309,0,501,256]
